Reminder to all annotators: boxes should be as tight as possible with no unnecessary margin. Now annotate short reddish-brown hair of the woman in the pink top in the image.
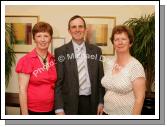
[32,22,53,38]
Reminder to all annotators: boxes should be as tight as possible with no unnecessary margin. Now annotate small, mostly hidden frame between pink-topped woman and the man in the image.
[51,37,65,55]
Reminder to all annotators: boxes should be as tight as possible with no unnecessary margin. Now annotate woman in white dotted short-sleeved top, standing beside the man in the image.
[101,25,145,115]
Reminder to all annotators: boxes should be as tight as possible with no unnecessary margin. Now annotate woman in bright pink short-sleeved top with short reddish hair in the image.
[16,22,57,115]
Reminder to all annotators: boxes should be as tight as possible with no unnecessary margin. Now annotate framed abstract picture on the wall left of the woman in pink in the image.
[5,15,39,53]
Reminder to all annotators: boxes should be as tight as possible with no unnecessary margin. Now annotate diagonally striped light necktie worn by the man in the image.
[77,48,86,89]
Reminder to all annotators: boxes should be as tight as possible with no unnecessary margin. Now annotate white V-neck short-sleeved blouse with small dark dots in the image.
[101,57,145,115]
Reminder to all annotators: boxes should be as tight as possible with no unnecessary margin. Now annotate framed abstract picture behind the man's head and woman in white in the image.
[83,16,116,55]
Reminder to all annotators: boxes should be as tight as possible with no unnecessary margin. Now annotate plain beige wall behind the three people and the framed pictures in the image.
[5,5,155,92]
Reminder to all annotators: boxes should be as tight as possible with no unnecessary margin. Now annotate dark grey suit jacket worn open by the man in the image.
[54,42,105,115]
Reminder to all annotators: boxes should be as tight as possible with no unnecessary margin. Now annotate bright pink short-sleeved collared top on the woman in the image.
[16,49,57,112]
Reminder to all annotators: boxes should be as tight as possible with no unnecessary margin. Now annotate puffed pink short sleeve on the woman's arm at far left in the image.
[16,56,32,74]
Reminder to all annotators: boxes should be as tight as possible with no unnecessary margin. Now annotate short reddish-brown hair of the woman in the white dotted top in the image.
[110,25,134,44]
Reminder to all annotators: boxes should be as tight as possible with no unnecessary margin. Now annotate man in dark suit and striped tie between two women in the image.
[54,15,105,115]
